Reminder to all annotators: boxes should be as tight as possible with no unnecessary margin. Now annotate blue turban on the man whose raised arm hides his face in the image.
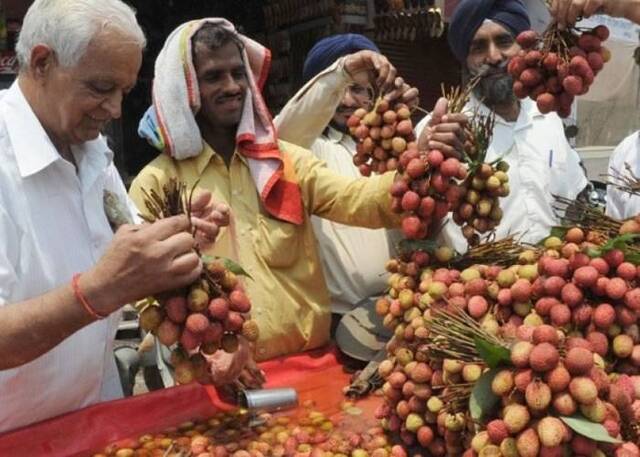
[302,33,380,83]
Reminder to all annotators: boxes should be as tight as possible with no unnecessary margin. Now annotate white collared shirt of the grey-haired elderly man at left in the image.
[0,82,131,432]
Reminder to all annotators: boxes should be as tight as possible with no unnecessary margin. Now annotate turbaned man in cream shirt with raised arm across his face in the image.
[275,34,459,324]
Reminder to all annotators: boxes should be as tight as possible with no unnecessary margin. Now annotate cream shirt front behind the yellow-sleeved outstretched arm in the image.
[311,127,393,314]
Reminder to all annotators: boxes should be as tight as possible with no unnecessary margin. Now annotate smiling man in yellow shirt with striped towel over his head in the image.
[130,19,399,360]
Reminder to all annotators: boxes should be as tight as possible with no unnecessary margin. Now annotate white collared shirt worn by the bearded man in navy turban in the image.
[416,97,588,252]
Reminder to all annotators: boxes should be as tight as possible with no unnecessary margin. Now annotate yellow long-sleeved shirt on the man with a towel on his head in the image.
[130,141,400,360]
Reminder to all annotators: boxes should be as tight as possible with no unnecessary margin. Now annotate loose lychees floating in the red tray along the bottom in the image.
[94,405,407,457]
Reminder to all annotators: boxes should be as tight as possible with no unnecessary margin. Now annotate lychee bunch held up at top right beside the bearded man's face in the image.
[508,24,611,117]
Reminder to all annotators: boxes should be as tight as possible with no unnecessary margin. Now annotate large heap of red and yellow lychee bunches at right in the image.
[376,220,640,457]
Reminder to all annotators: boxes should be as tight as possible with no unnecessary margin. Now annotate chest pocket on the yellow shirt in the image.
[255,214,302,268]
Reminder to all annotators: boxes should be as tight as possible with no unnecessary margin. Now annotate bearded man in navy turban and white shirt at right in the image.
[416,0,588,251]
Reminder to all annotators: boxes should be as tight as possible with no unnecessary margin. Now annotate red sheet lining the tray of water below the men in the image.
[0,350,377,457]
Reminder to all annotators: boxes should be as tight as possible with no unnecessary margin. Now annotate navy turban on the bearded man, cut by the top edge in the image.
[447,0,531,63]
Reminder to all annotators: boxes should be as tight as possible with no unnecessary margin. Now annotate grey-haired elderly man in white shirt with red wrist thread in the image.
[0,0,218,432]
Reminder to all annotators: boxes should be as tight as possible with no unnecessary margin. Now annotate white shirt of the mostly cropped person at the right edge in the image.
[607,132,640,220]
